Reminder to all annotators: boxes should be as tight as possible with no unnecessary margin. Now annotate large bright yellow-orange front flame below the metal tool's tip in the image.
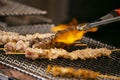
[55,28,97,44]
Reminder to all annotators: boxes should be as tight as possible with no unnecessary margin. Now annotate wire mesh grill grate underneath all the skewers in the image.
[0,24,120,80]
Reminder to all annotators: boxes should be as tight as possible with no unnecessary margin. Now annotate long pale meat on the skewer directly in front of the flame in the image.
[25,48,112,60]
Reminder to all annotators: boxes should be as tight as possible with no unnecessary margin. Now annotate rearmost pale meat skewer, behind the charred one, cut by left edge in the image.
[0,31,54,45]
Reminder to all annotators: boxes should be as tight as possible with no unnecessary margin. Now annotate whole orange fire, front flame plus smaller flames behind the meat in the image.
[51,19,97,44]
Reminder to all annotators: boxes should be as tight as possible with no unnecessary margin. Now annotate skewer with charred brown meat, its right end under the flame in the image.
[4,38,87,52]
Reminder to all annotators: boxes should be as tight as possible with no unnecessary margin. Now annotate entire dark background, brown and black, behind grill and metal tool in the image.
[8,0,120,47]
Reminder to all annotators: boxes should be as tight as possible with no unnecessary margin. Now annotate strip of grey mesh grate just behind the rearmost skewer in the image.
[3,24,54,35]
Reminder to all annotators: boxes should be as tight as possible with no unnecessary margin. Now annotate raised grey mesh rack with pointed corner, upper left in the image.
[0,0,47,16]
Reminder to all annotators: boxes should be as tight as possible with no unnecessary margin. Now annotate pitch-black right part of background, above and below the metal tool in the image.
[68,0,120,47]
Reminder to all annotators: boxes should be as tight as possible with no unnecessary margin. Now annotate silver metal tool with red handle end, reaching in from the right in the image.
[77,8,120,30]
